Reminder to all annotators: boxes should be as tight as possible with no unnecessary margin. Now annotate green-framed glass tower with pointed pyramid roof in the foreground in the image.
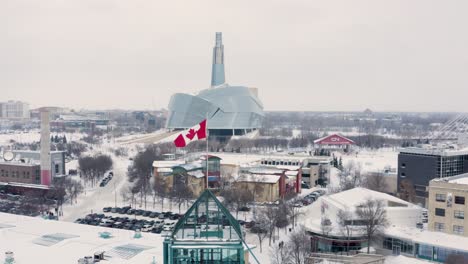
[164,190,258,264]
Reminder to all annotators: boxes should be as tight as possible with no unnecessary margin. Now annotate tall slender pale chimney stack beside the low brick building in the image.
[40,108,51,186]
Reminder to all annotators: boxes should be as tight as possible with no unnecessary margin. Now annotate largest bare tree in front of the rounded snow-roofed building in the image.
[356,199,388,253]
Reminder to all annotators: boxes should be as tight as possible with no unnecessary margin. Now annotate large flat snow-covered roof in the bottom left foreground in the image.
[0,213,164,264]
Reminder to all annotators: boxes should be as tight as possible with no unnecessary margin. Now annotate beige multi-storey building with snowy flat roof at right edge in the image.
[427,174,468,236]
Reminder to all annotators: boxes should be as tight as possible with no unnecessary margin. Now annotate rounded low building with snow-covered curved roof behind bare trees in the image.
[304,188,422,252]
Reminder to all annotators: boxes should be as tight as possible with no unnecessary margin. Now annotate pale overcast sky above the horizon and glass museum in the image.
[0,0,468,112]
